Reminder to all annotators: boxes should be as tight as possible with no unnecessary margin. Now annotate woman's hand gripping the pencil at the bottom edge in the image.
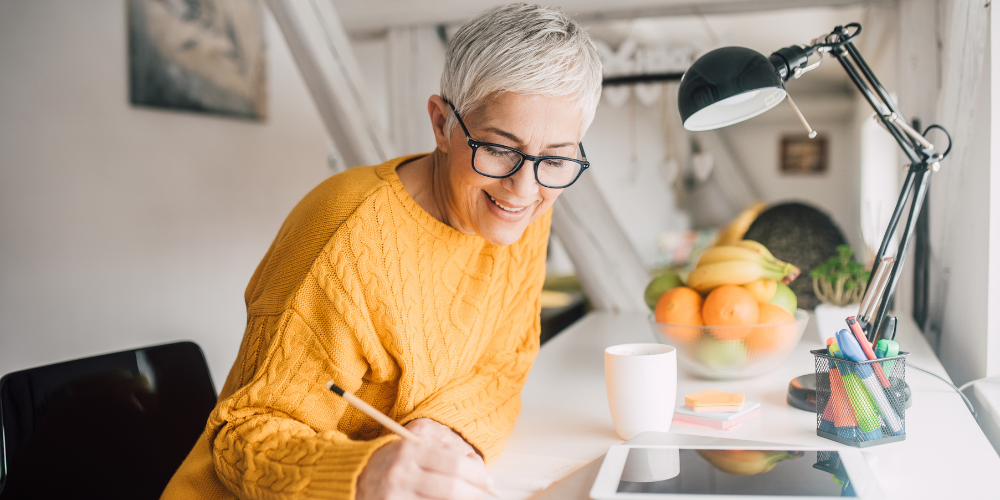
[356,434,489,500]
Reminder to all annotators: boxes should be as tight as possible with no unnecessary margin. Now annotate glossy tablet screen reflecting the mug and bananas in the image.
[618,447,857,497]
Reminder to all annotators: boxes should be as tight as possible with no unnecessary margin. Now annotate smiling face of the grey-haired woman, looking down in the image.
[428,93,583,245]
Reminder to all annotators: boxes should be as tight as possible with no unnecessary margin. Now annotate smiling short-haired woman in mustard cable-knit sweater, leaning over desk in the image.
[163,4,601,499]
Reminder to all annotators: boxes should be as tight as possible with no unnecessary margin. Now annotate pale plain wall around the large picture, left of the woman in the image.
[0,0,330,388]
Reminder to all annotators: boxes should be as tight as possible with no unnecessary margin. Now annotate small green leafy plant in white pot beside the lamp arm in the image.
[809,245,871,339]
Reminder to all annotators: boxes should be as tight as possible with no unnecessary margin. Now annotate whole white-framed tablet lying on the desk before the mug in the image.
[590,445,882,500]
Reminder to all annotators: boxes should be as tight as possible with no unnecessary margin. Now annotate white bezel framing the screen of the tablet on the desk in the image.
[590,444,883,500]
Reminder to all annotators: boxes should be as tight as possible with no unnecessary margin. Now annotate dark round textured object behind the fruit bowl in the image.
[743,203,847,311]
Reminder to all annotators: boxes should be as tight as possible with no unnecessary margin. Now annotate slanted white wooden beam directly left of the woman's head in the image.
[265,0,396,169]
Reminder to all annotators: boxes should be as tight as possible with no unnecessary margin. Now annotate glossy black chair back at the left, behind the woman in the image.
[0,342,216,500]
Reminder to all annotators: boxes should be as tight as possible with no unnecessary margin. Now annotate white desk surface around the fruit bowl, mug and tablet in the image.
[504,313,1000,500]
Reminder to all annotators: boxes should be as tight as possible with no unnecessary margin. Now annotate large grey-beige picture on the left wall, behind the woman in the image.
[128,0,267,120]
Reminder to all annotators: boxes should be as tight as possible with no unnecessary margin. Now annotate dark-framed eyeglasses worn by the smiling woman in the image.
[445,100,590,189]
